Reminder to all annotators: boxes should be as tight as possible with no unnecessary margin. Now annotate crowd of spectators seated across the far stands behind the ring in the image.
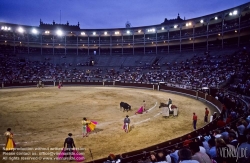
[0,50,250,95]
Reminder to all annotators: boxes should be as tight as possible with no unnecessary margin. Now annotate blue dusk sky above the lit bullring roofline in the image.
[0,0,249,29]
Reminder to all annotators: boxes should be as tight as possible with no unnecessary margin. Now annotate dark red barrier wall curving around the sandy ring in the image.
[2,80,222,163]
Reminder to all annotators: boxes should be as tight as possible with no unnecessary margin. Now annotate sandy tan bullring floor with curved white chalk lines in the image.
[0,87,214,163]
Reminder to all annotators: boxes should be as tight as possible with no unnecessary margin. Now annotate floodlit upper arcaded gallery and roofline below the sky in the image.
[0,3,250,56]
